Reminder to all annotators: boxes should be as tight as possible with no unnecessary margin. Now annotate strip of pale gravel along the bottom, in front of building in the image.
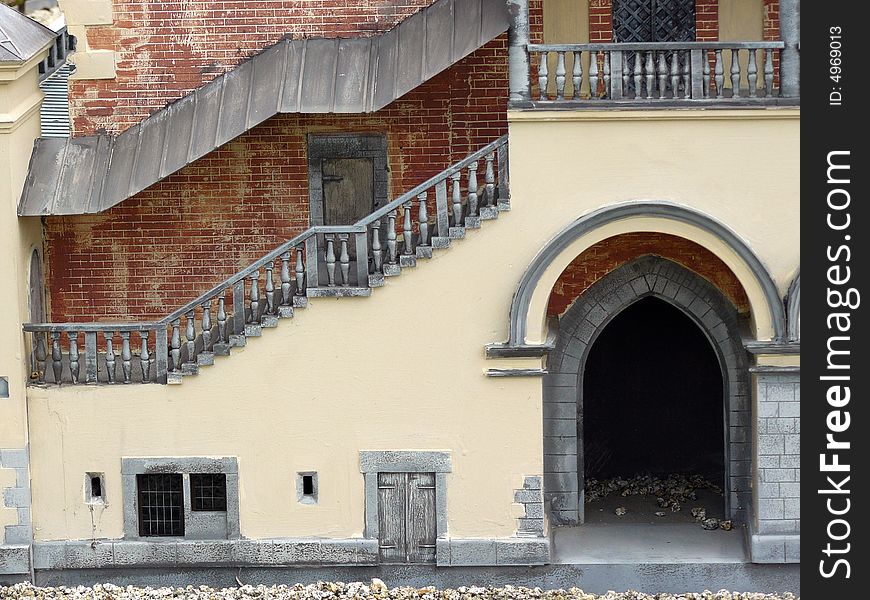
[0,579,796,600]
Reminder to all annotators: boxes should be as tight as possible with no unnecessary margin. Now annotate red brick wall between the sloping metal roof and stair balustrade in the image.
[45,35,507,321]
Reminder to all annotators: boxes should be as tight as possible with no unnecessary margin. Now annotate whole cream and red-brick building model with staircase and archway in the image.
[0,0,800,581]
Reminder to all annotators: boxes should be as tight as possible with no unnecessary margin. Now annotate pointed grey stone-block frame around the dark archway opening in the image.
[543,255,751,525]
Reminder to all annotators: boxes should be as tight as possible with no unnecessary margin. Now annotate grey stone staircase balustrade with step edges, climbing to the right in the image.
[24,136,510,385]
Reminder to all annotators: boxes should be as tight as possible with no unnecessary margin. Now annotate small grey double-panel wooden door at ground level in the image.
[378,473,437,563]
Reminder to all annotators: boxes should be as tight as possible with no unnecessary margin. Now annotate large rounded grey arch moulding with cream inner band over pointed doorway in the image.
[506,201,786,348]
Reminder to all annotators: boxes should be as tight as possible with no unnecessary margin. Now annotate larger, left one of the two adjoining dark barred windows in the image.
[136,473,184,537]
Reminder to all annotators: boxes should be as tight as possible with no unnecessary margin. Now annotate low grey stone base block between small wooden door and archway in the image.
[435,537,550,567]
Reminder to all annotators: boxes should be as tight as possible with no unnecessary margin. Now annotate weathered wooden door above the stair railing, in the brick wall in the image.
[321,158,375,225]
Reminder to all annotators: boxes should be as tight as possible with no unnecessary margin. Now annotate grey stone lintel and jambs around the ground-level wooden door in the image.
[359,450,453,544]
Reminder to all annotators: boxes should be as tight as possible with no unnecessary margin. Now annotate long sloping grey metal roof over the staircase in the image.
[18,0,509,216]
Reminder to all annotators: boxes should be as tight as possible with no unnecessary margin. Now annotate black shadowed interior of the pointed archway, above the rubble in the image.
[583,298,725,486]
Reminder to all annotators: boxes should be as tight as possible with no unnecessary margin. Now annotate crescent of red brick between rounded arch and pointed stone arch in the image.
[547,232,749,316]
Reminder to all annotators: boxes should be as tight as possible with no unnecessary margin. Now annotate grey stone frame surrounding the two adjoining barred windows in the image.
[121,456,241,545]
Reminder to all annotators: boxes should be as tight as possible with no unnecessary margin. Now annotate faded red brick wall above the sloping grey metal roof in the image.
[70,0,433,135]
